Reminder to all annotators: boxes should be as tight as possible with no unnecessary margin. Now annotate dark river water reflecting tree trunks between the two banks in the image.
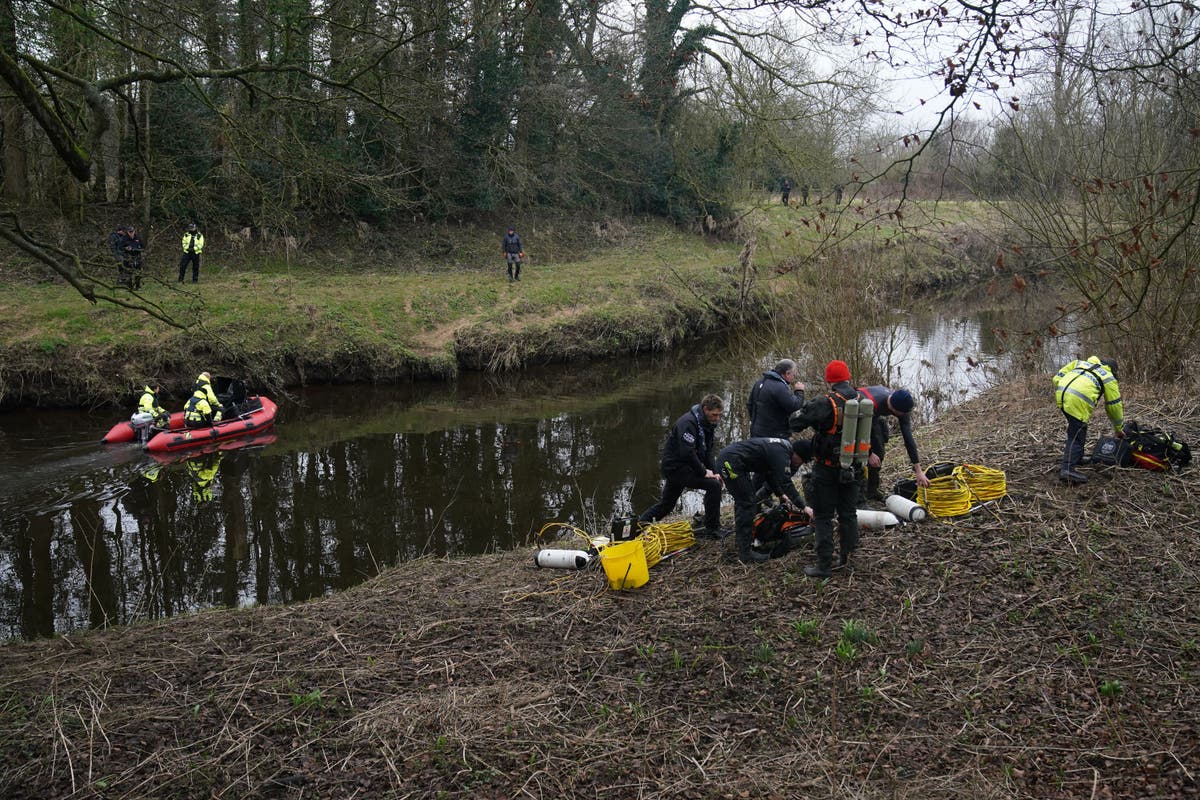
[0,303,1070,638]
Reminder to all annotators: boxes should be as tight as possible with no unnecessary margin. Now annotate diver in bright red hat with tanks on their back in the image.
[788,361,862,578]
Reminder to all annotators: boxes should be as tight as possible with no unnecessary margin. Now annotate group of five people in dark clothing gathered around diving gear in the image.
[638,359,929,578]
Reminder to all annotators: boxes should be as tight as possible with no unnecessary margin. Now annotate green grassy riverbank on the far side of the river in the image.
[0,206,988,407]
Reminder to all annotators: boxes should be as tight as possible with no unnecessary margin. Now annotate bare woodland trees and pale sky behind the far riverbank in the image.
[0,0,1200,374]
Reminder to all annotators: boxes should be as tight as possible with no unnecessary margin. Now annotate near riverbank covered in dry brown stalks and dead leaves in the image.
[0,377,1200,800]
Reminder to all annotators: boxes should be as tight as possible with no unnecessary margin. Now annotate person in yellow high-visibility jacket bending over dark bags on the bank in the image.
[1054,355,1124,483]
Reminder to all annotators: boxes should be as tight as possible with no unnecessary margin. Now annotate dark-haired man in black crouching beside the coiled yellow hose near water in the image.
[638,395,725,539]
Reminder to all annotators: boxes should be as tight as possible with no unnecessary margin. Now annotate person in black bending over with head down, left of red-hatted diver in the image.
[716,437,812,564]
